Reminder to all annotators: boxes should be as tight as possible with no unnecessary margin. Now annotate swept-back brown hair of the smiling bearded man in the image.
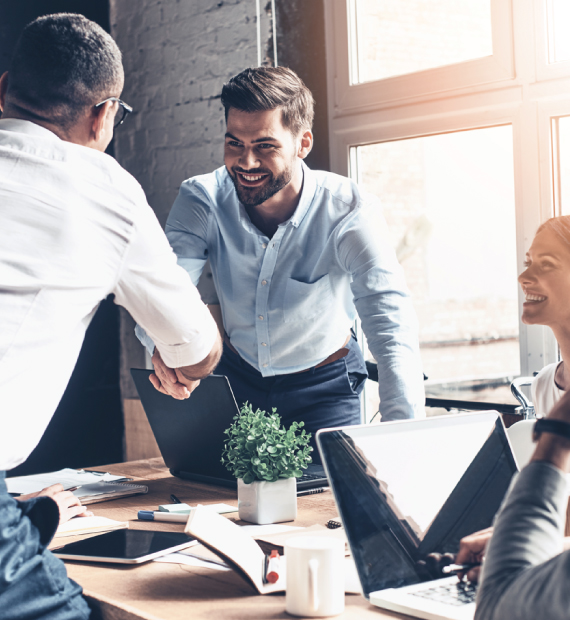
[222,67,315,135]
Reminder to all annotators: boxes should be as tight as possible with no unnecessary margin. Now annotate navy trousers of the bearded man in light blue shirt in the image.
[214,336,368,463]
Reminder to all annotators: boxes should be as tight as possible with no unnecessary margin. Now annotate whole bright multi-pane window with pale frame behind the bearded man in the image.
[325,0,560,418]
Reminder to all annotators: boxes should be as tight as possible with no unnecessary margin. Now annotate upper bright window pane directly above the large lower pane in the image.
[352,0,493,83]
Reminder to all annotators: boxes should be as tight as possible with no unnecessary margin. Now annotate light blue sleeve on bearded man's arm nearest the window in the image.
[337,201,425,421]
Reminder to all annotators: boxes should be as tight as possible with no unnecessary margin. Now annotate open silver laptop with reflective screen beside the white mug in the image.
[317,411,517,620]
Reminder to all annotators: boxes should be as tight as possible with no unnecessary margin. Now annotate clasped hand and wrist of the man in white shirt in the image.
[149,335,222,400]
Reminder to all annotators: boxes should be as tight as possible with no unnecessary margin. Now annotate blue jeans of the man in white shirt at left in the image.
[0,472,90,620]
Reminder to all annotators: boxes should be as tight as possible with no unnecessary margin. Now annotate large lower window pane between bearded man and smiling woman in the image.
[352,126,520,411]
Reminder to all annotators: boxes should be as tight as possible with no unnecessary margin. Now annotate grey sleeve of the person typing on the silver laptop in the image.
[475,462,570,620]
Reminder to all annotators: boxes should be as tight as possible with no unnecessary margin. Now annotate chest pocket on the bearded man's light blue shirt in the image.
[283,273,333,323]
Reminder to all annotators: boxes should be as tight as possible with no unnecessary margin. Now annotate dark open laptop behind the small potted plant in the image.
[131,368,328,491]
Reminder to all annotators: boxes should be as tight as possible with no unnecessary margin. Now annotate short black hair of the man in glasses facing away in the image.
[6,13,124,128]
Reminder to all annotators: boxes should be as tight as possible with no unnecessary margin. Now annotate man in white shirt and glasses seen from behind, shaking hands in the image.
[0,14,221,620]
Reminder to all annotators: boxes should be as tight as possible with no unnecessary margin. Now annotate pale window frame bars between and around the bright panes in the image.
[325,0,570,376]
